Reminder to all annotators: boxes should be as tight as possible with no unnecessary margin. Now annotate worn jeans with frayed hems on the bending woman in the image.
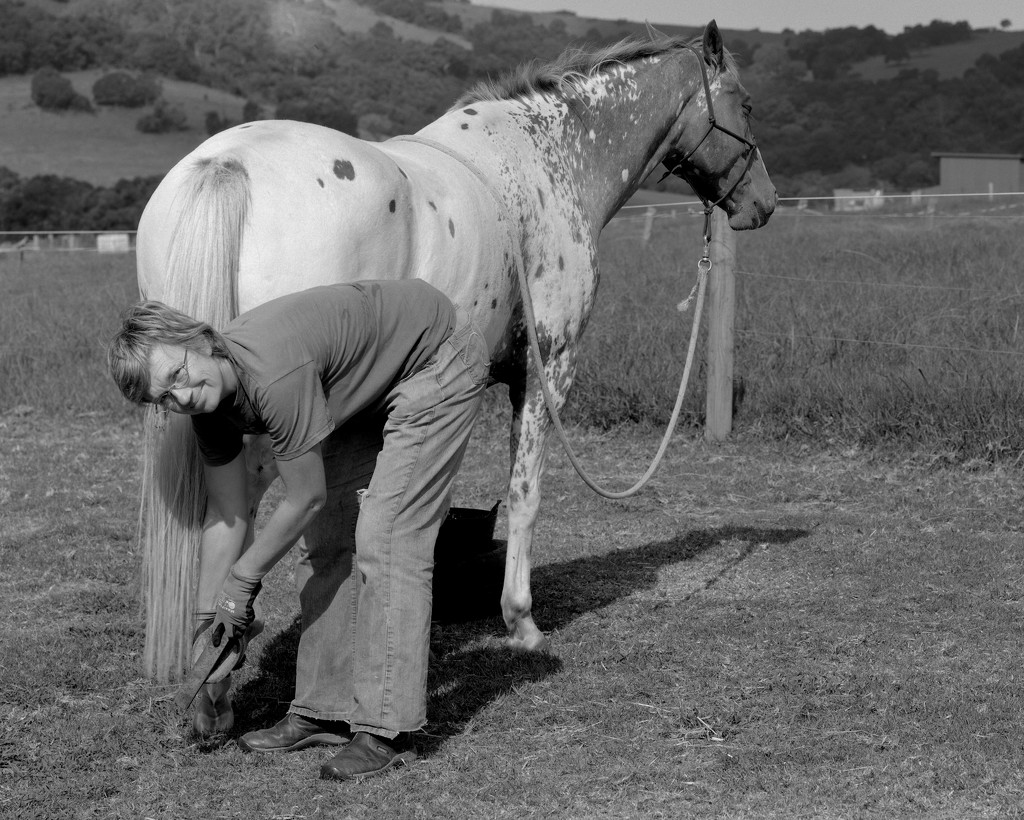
[291,309,489,738]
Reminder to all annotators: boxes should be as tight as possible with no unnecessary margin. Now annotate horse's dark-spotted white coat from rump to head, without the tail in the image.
[138,27,775,671]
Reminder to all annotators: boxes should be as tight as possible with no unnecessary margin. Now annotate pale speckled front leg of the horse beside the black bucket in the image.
[502,351,573,652]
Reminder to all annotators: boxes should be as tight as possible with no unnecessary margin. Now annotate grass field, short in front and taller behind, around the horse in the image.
[0,209,1024,820]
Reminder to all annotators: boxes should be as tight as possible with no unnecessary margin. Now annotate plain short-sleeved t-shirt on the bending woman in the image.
[191,279,456,465]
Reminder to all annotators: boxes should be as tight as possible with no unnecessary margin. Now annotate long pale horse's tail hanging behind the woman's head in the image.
[139,158,250,683]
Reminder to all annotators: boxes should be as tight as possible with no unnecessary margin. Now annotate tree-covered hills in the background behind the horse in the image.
[0,0,1024,210]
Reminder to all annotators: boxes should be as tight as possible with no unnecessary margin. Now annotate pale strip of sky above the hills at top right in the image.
[472,0,1024,34]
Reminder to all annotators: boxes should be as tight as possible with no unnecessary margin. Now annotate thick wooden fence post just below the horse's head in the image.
[705,208,736,441]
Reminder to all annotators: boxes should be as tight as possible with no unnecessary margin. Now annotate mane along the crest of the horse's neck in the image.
[450,30,736,111]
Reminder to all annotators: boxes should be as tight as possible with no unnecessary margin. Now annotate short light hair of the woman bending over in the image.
[106,301,230,404]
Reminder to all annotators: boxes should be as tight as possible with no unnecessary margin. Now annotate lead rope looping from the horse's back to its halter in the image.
[390,135,712,499]
